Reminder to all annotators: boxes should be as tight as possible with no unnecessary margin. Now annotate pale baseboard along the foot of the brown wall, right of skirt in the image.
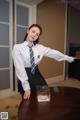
[46,75,64,85]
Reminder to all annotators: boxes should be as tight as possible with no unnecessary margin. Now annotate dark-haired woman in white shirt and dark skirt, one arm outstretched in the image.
[12,24,74,99]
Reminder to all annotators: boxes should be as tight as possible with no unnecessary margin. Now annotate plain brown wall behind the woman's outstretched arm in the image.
[37,0,66,78]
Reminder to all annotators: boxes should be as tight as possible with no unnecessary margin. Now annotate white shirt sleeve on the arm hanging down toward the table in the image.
[12,45,30,91]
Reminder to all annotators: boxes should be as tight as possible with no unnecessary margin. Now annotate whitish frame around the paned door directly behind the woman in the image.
[13,0,37,92]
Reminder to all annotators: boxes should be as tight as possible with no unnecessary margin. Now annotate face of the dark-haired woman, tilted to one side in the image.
[27,26,40,42]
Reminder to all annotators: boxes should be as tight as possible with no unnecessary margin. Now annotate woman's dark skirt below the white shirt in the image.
[18,66,47,96]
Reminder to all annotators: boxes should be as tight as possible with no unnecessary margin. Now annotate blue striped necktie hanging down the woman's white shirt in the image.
[28,45,35,74]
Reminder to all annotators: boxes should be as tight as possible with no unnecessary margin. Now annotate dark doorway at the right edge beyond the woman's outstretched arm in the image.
[67,5,80,79]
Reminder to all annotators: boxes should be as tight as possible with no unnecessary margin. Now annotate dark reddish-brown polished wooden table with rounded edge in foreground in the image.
[18,87,80,120]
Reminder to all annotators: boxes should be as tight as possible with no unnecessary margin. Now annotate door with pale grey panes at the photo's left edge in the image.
[0,0,13,98]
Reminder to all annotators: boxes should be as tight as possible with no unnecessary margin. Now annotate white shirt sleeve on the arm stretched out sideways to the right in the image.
[42,46,74,62]
